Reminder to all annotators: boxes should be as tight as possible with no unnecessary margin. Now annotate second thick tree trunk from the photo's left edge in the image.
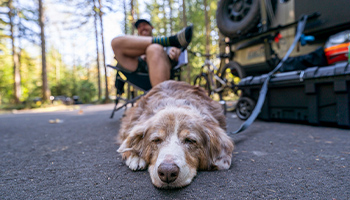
[39,0,50,102]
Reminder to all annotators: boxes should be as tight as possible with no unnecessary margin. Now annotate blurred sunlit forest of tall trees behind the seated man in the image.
[0,0,227,109]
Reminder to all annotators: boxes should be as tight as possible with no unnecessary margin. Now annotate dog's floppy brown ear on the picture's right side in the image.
[207,125,234,170]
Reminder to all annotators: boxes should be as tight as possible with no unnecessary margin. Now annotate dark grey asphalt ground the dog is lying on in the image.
[0,104,350,200]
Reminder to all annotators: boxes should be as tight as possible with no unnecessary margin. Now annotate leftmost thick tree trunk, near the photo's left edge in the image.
[8,0,21,104]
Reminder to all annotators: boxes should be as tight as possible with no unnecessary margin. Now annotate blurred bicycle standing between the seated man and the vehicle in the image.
[190,52,241,112]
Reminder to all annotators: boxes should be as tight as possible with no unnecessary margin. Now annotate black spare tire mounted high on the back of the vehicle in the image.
[216,0,260,38]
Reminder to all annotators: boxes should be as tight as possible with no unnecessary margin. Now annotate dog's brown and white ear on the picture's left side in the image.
[117,124,147,154]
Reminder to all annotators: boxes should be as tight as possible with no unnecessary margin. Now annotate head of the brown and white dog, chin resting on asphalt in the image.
[118,106,233,188]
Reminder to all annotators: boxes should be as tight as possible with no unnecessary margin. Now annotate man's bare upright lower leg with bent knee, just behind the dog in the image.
[146,44,171,87]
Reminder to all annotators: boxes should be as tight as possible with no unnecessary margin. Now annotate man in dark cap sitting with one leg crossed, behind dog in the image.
[111,19,193,87]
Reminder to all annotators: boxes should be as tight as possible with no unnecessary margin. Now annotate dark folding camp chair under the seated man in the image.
[107,50,188,118]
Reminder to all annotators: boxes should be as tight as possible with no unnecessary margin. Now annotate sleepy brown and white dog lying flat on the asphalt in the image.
[118,81,234,189]
